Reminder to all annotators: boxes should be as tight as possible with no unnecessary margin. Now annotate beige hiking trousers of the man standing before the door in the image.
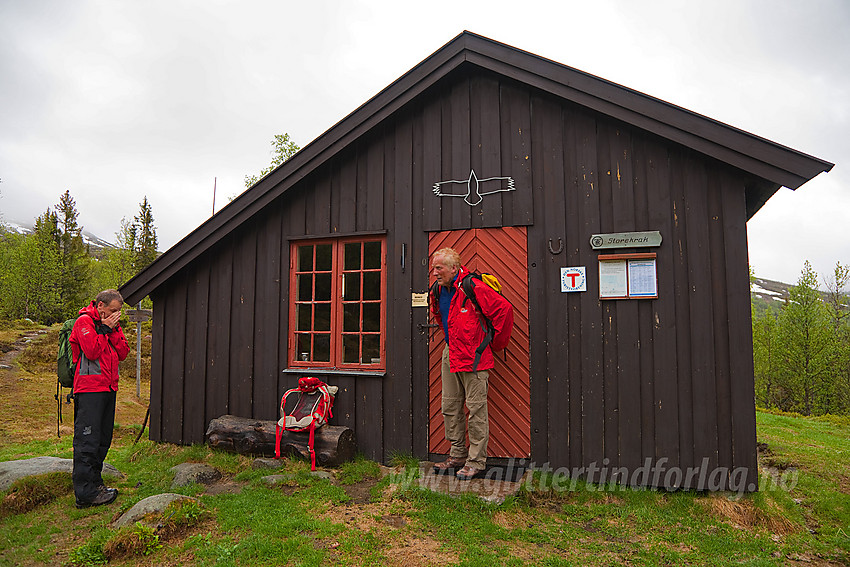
[441,345,490,469]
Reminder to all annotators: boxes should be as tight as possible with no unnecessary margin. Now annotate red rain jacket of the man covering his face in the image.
[68,301,130,393]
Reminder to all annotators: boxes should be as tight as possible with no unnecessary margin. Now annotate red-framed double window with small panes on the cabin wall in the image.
[287,236,387,370]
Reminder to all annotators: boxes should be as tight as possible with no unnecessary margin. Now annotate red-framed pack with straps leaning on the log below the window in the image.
[274,376,339,470]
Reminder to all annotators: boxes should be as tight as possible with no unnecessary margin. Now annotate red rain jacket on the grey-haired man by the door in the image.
[431,266,514,372]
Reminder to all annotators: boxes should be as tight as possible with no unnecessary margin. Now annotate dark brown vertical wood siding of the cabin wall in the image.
[151,65,756,483]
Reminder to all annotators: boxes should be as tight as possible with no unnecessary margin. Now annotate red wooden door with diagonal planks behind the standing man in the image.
[428,227,531,458]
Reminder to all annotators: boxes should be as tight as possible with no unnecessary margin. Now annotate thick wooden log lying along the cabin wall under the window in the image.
[206,415,357,467]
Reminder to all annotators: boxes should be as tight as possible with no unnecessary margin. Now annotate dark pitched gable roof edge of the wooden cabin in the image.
[121,32,833,304]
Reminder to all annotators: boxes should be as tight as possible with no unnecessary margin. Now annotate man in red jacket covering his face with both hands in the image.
[68,289,130,508]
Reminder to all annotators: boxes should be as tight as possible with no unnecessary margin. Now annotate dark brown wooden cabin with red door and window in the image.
[121,32,832,490]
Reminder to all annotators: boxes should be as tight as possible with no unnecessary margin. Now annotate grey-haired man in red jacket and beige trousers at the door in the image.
[431,248,514,480]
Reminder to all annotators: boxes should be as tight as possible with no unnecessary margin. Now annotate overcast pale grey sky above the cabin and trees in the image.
[0,0,850,283]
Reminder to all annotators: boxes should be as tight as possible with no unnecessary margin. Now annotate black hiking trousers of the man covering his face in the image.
[72,392,116,502]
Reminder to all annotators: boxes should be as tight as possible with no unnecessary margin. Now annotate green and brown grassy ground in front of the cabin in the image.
[0,322,850,567]
